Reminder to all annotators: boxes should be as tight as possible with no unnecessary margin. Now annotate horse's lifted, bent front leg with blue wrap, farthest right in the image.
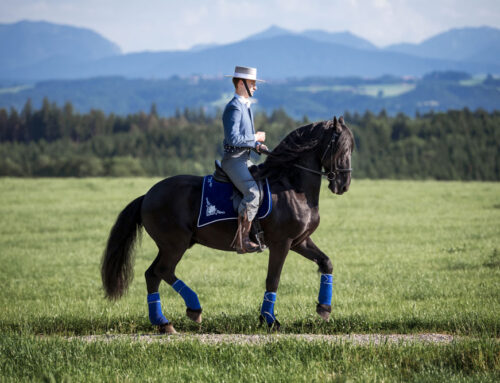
[292,237,333,321]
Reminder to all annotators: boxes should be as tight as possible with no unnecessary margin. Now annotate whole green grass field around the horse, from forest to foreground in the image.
[0,178,500,381]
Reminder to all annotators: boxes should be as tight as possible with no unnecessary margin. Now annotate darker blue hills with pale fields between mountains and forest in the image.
[0,72,500,119]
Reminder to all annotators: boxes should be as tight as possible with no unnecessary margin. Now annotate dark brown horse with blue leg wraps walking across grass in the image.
[101,117,354,333]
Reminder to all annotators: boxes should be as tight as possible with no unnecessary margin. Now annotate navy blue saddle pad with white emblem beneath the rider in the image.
[198,175,273,227]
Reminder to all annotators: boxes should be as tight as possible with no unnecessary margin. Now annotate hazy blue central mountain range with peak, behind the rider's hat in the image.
[79,35,500,79]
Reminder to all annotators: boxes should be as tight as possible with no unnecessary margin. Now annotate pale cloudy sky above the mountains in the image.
[0,0,500,53]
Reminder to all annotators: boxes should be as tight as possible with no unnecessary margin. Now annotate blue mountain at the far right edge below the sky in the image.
[386,27,500,64]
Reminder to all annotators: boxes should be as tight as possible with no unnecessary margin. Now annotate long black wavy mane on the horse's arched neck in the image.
[257,118,354,180]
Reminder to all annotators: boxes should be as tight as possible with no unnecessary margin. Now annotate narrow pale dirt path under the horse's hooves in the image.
[67,333,464,345]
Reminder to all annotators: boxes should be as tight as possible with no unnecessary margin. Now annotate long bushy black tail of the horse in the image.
[101,196,144,299]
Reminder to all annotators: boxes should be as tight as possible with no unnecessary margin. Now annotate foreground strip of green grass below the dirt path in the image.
[0,336,500,382]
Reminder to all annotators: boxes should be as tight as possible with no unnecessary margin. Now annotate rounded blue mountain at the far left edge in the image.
[0,21,121,71]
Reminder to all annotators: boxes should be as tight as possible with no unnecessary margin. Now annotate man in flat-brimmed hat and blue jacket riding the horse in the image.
[221,66,267,253]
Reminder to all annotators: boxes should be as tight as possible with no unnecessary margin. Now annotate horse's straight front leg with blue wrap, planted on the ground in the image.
[260,241,291,331]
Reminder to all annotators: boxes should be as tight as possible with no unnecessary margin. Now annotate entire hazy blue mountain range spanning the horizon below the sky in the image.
[0,22,500,81]
